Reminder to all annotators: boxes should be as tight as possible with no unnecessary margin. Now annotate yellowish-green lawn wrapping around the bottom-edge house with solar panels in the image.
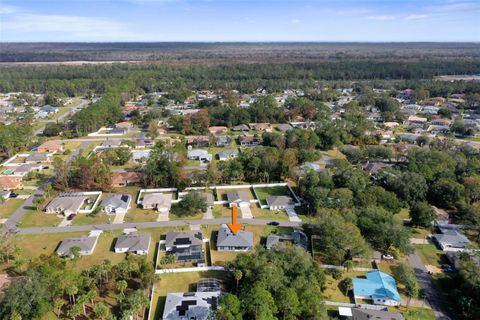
[150,271,232,319]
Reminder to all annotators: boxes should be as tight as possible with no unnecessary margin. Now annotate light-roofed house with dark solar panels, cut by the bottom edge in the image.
[162,291,220,320]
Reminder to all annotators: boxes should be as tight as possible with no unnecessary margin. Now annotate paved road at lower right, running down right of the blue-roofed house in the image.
[408,252,451,320]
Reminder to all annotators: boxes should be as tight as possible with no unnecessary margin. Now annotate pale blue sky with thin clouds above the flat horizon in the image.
[0,0,480,42]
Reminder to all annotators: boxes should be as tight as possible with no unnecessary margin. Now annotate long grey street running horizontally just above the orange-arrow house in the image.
[6,218,302,234]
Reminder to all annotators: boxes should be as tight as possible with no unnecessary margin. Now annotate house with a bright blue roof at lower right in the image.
[353,271,400,306]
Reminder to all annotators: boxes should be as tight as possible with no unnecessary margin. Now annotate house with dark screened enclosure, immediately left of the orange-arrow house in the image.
[165,231,204,262]
